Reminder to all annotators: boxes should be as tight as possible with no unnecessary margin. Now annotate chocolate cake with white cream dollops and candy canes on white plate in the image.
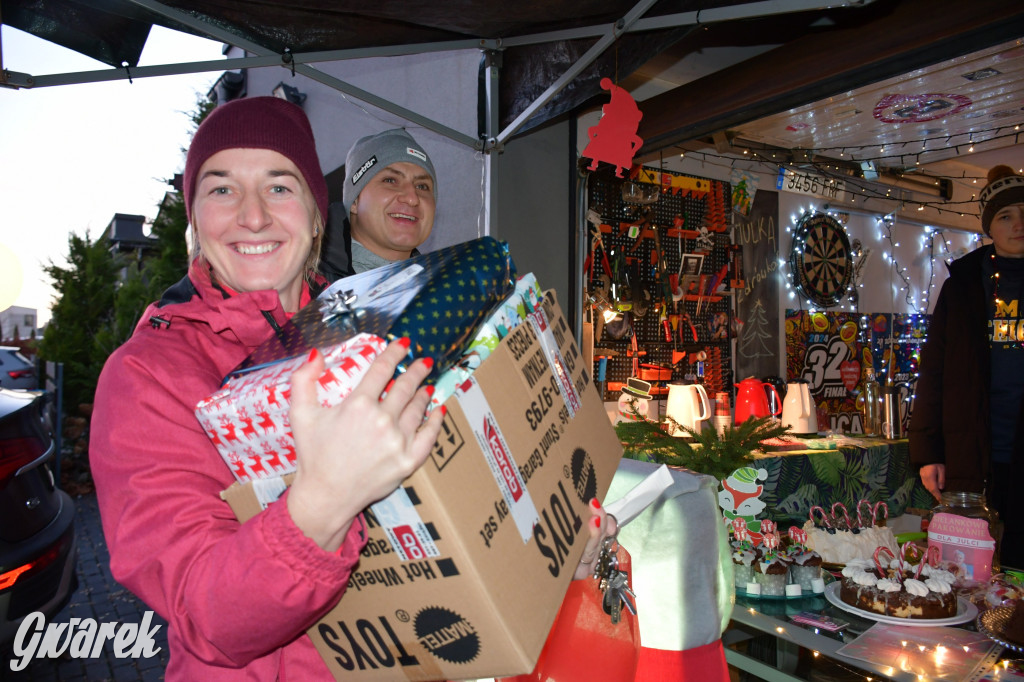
[839,543,956,619]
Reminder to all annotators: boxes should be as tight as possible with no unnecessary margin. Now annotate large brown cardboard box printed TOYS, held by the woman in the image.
[224,293,622,680]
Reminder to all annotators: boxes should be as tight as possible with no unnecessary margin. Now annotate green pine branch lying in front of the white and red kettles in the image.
[615,409,791,480]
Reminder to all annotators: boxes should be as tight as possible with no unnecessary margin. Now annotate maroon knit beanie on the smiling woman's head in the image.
[184,97,328,222]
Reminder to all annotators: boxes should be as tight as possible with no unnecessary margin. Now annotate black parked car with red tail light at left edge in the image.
[0,388,78,651]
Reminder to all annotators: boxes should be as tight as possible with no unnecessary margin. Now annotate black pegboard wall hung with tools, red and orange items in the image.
[585,167,742,402]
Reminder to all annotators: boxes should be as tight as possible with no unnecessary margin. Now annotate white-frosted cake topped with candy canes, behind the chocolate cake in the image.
[804,500,899,564]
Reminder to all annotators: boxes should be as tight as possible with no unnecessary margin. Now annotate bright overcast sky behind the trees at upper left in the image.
[0,26,222,324]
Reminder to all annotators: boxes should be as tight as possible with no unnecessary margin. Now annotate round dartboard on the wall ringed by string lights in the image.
[790,213,853,306]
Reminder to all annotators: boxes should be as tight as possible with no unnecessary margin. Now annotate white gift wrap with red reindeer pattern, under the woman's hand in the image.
[196,334,387,481]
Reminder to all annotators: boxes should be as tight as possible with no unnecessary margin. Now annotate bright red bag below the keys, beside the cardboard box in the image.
[496,546,640,682]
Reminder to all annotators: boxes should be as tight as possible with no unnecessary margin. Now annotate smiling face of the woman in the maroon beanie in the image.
[193,148,316,311]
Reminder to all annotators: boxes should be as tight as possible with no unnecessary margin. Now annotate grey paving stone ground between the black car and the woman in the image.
[0,494,167,682]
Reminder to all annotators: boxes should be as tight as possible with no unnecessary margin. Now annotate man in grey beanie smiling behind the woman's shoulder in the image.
[321,128,437,281]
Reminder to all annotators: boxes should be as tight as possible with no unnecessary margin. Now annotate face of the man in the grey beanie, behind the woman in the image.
[350,161,435,260]
